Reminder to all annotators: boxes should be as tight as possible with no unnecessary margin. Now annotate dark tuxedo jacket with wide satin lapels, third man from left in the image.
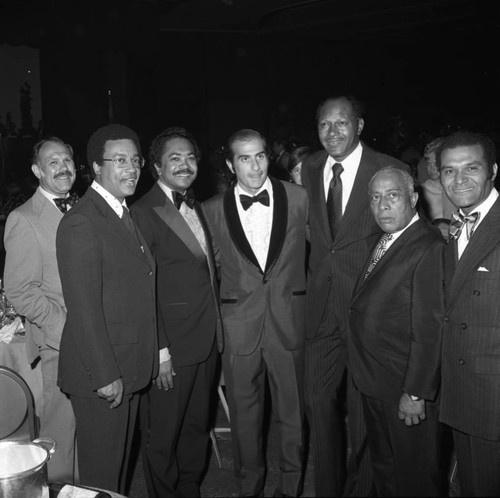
[131,183,223,367]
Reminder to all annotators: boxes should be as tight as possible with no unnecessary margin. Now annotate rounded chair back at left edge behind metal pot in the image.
[0,365,38,441]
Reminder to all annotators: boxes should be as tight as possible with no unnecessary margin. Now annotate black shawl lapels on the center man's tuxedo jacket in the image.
[224,178,288,275]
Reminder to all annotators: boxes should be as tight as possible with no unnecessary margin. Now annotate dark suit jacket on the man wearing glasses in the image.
[56,188,158,397]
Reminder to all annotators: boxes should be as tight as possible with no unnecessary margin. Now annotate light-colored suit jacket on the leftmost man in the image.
[4,188,66,363]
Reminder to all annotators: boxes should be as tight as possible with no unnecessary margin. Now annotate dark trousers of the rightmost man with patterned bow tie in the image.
[453,429,500,496]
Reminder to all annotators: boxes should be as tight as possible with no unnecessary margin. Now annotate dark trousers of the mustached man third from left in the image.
[141,344,218,498]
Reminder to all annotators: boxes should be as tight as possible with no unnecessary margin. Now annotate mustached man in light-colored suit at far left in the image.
[3,137,75,482]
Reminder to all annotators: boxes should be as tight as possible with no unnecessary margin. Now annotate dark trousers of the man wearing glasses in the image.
[70,394,139,494]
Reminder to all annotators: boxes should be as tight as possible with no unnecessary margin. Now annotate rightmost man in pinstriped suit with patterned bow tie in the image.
[436,132,500,496]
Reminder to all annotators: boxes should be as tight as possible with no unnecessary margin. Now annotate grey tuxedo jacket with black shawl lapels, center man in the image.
[203,179,308,355]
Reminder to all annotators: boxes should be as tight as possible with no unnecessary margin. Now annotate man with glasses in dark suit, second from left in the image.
[56,124,158,493]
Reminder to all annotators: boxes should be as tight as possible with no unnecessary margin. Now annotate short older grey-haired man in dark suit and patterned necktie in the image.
[349,167,445,496]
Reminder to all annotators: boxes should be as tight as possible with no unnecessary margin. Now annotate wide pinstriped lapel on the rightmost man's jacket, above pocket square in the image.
[447,197,500,307]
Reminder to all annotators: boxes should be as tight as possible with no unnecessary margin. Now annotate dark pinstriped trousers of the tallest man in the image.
[305,334,373,496]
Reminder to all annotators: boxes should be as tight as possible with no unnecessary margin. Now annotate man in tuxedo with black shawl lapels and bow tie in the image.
[203,130,307,496]
